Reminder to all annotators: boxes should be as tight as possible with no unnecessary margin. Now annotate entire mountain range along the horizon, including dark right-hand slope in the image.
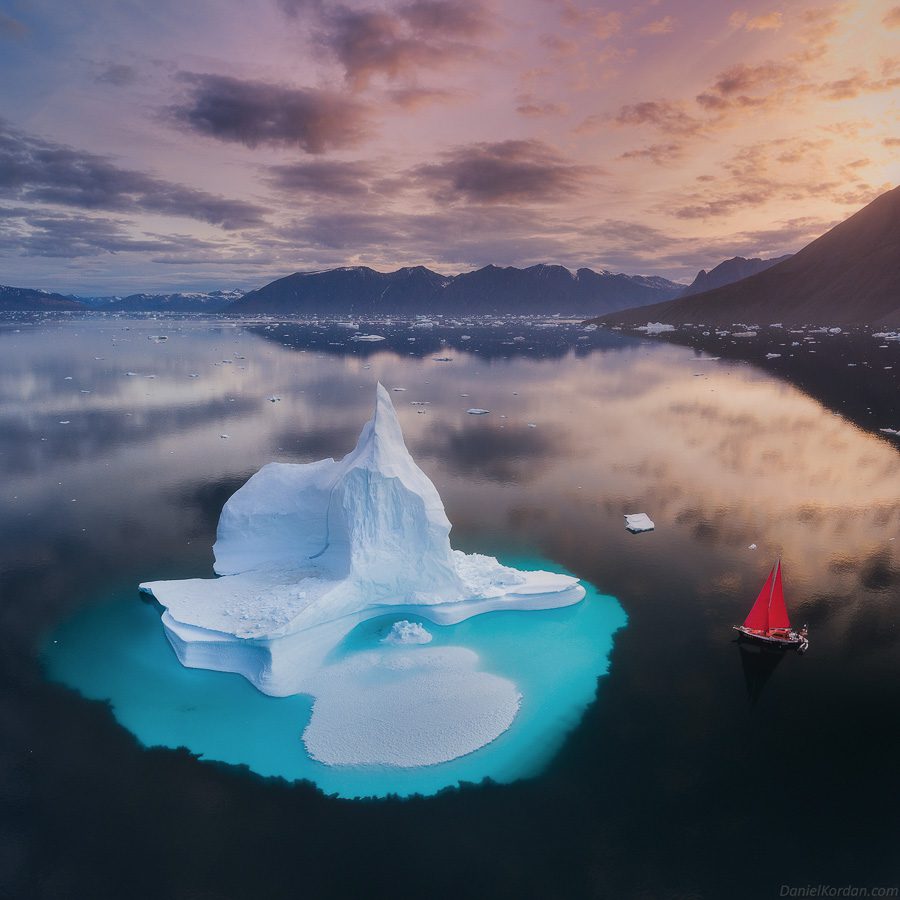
[0,188,900,326]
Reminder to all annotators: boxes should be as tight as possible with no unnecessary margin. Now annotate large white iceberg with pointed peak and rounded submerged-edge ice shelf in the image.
[141,384,584,766]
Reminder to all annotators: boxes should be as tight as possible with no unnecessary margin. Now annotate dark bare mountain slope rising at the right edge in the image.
[594,187,900,327]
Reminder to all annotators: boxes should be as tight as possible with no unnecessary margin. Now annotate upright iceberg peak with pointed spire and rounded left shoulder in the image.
[213,384,466,613]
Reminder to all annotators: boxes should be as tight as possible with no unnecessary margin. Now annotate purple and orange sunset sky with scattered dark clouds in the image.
[0,0,900,294]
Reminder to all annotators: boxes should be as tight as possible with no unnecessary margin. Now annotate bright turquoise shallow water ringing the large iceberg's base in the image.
[43,559,627,797]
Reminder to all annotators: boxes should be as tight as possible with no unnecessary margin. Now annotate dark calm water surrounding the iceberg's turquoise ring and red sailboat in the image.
[0,318,900,900]
